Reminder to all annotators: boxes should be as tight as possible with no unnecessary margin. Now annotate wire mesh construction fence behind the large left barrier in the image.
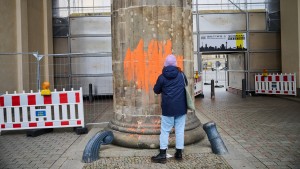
[0,52,113,125]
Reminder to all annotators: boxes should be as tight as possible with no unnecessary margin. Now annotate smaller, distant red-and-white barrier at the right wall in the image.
[255,74,297,96]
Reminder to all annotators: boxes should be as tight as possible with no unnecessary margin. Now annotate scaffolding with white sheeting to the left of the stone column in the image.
[53,0,113,95]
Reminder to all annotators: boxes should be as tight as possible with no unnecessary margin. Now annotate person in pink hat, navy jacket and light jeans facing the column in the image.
[151,55,187,163]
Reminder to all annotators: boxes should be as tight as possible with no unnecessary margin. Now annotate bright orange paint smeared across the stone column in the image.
[124,39,183,93]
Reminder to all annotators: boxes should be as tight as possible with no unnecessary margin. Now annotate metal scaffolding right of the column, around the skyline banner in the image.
[193,0,281,92]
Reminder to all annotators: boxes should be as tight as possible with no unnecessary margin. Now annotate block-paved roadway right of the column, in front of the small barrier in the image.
[196,88,300,169]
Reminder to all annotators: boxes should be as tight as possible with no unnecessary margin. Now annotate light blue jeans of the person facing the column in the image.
[159,115,186,149]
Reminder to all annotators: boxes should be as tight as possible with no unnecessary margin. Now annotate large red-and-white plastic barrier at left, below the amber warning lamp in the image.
[0,88,84,133]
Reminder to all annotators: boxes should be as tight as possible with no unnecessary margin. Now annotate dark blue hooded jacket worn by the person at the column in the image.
[153,66,187,116]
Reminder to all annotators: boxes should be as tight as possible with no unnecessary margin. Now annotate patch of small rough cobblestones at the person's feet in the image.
[84,153,231,169]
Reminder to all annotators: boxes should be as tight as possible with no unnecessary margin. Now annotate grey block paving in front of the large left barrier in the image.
[0,129,79,169]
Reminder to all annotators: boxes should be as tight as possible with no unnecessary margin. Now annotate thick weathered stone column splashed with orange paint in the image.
[109,0,205,148]
